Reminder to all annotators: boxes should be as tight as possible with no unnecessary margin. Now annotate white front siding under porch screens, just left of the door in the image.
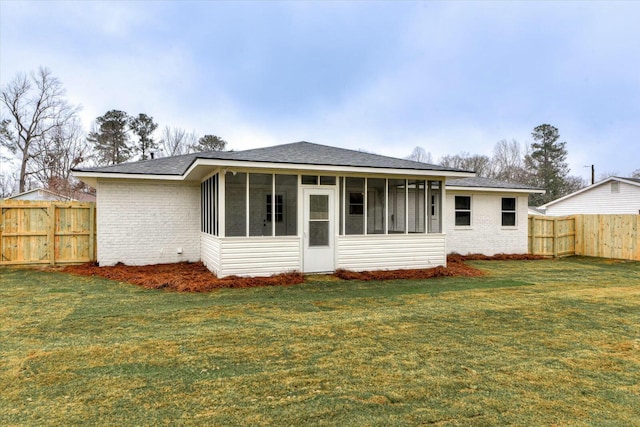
[218,236,302,277]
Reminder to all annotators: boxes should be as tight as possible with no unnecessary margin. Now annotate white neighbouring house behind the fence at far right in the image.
[539,176,640,216]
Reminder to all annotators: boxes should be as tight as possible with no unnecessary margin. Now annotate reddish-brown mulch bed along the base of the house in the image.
[61,254,542,292]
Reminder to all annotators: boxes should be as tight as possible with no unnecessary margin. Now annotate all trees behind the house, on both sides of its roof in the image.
[0,67,640,206]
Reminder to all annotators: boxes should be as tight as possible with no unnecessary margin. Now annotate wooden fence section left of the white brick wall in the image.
[0,200,96,265]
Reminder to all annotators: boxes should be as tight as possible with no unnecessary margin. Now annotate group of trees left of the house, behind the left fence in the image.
[0,67,227,198]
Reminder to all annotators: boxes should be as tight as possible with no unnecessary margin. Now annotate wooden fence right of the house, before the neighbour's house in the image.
[529,215,640,261]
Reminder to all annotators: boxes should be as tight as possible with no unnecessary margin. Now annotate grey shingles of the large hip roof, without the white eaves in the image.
[73,142,470,175]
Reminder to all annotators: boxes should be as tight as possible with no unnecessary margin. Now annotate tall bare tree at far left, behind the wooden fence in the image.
[0,67,77,192]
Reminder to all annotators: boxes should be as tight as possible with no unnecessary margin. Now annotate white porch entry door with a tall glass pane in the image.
[303,188,335,273]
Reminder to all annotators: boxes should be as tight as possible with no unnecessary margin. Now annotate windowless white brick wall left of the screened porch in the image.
[97,180,200,265]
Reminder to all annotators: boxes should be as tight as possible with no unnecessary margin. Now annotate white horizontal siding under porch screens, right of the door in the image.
[337,234,447,271]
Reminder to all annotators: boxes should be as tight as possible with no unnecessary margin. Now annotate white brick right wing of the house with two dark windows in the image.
[444,177,544,255]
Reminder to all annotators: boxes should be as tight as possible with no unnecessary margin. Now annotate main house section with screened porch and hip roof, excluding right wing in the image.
[73,142,474,277]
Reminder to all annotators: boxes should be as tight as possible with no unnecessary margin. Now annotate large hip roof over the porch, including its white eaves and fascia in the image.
[73,142,474,187]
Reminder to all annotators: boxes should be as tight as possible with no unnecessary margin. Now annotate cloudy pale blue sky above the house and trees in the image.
[0,0,640,180]
